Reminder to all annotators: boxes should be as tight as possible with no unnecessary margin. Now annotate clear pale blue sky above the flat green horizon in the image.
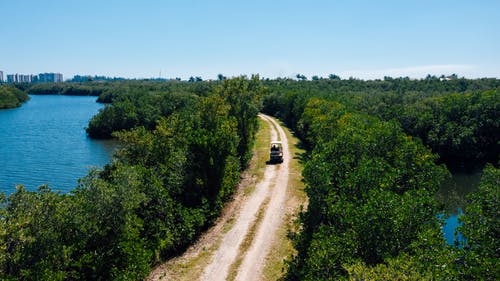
[0,0,500,79]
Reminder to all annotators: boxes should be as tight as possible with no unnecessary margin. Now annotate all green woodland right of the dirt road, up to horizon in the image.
[264,79,500,280]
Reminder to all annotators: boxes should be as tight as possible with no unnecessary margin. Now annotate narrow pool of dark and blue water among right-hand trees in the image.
[436,170,481,245]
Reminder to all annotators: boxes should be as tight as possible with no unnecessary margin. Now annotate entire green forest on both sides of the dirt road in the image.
[0,75,500,280]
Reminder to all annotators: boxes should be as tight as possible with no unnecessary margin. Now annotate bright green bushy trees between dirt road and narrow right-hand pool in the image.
[289,99,447,280]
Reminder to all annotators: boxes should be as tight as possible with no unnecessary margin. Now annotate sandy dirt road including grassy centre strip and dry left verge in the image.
[147,115,292,281]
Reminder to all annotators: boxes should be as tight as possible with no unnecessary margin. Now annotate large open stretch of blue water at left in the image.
[0,96,116,194]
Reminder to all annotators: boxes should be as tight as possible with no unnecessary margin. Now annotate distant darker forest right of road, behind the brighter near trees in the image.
[263,77,500,169]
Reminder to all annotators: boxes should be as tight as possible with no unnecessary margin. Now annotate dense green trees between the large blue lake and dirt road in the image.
[0,77,261,280]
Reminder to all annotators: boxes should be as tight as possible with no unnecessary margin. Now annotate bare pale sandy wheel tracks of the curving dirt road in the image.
[201,114,291,281]
